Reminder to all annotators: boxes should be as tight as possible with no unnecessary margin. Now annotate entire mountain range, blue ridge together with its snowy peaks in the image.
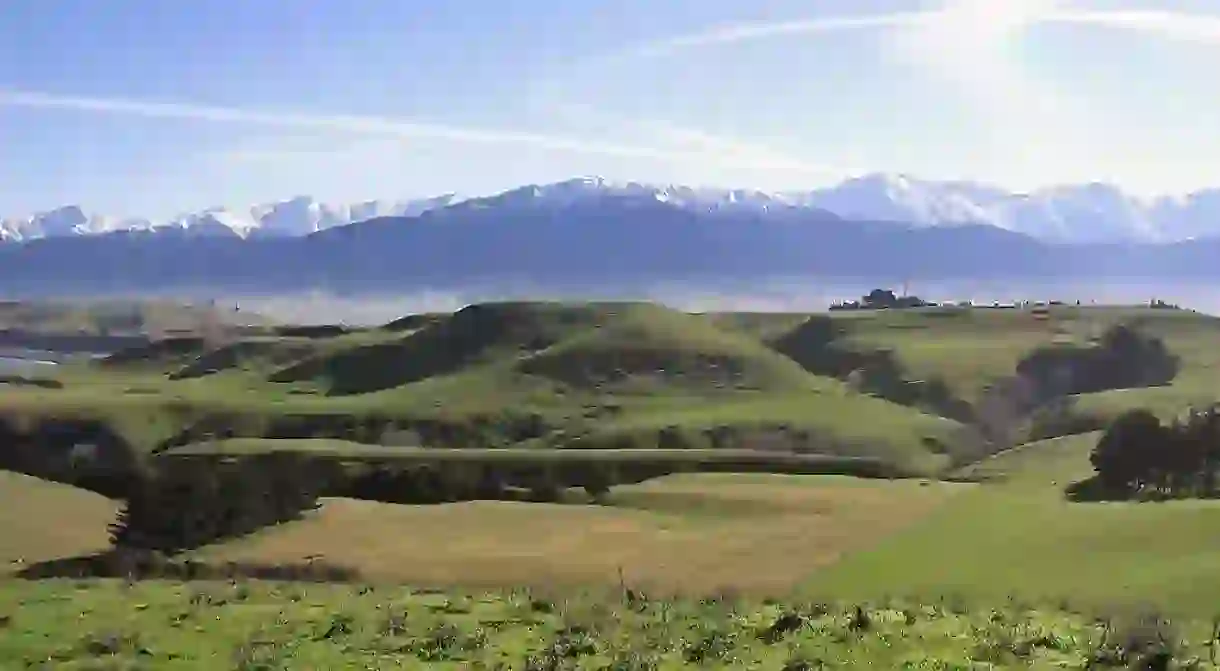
[0,177,1220,296]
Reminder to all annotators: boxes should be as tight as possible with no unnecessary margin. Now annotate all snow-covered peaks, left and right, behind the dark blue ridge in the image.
[7,173,1220,244]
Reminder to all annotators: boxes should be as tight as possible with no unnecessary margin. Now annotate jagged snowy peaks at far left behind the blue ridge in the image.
[0,194,459,242]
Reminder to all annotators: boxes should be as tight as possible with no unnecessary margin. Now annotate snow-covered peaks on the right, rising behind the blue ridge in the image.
[439,173,1220,243]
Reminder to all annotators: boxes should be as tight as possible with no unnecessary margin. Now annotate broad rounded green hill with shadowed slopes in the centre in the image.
[0,303,969,480]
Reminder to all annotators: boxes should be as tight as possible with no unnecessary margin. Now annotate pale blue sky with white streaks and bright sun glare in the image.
[0,0,1220,218]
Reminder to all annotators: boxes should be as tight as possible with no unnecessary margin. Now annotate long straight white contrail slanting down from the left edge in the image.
[0,90,824,168]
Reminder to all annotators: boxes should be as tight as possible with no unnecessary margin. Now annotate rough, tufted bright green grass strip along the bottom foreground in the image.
[0,582,1215,670]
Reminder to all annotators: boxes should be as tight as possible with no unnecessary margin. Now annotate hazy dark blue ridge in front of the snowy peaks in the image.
[0,190,1220,294]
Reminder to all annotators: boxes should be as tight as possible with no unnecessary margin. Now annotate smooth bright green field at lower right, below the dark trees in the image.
[809,434,1220,616]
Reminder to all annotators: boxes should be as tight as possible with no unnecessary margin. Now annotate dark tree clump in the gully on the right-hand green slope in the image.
[1016,325,1181,400]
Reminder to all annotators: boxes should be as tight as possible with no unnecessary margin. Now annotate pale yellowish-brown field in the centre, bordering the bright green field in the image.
[203,476,966,593]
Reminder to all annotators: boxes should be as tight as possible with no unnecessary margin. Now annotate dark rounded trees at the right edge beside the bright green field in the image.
[1089,406,1220,497]
